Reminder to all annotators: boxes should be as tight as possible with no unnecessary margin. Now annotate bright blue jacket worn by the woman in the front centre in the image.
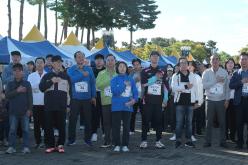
[110,74,138,112]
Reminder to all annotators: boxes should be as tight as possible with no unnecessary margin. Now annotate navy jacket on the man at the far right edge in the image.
[229,69,248,105]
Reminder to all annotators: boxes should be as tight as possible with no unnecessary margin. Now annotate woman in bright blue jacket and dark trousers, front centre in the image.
[110,62,138,152]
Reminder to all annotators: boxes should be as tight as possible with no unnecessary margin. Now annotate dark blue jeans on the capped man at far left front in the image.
[9,115,29,148]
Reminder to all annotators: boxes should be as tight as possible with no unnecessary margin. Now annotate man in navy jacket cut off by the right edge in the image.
[229,53,248,149]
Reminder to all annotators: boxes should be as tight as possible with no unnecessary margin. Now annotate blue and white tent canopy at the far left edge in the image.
[0,37,69,63]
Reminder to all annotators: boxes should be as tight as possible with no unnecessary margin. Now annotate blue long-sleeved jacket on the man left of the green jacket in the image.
[67,65,96,100]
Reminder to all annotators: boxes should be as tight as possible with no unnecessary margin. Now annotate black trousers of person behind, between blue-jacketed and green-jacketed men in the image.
[91,92,103,134]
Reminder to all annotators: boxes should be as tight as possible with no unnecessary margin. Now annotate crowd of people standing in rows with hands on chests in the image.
[0,51,248,154]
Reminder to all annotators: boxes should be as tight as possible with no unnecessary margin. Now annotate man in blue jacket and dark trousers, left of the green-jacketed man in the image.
[67,51,96,146]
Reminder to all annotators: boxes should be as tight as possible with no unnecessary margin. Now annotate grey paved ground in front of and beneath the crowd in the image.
[0,114,248,165]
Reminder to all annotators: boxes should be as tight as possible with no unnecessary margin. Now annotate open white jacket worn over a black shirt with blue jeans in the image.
[171,73,203,105]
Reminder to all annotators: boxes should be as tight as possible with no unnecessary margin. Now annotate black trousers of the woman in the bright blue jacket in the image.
[112,111,132,146]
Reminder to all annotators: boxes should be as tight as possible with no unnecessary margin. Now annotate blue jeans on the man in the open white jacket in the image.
[176,105,193,141]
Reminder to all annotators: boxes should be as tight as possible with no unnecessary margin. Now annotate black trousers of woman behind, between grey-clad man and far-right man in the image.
[226,99,236,140]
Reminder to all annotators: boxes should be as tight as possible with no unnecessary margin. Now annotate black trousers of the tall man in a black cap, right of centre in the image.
[141,103,163,141]
